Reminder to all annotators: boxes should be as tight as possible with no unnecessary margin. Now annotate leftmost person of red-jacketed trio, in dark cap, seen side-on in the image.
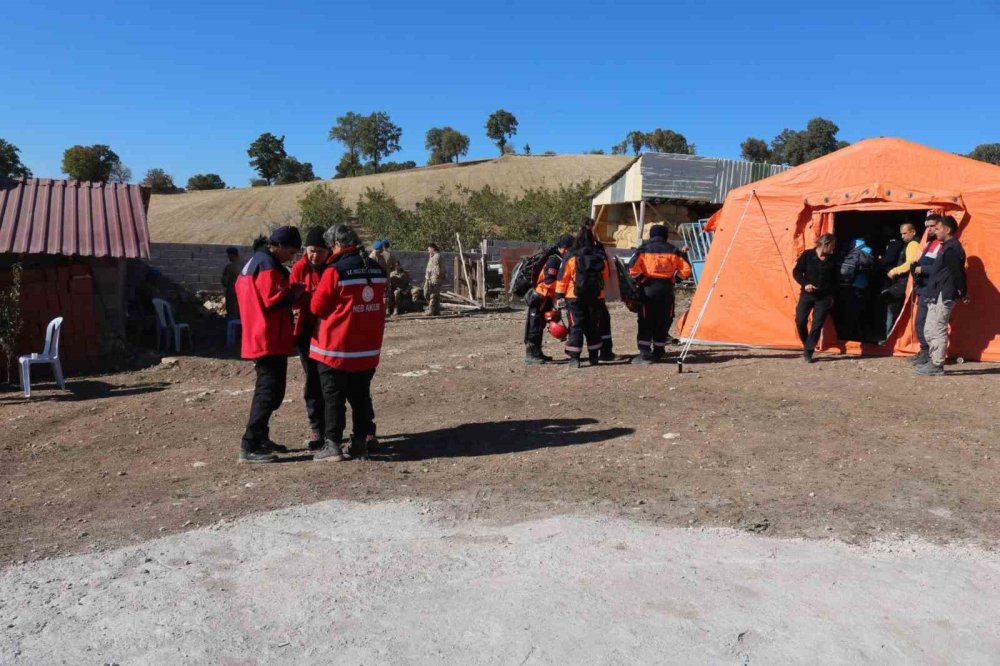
[236,226,302,463]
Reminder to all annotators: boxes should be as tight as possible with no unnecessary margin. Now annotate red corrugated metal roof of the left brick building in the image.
[0,178,149,258]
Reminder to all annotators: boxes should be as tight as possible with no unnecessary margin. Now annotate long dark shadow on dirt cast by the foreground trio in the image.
[371,418,635,461]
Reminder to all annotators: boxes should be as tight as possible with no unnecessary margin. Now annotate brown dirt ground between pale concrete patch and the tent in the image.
[0,298,1000,565]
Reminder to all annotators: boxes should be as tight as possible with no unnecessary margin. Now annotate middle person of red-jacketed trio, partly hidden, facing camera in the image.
[291,227,330,451]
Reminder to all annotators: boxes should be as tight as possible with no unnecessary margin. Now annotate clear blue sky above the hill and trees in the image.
[0,0,1000,186]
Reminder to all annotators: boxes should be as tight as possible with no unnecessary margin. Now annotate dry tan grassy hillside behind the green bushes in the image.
[149,155,634,243]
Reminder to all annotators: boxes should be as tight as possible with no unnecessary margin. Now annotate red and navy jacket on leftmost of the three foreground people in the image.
[236,250,294,358]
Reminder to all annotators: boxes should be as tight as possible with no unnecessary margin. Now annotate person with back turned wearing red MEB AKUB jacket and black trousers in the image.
[309,224,387,462]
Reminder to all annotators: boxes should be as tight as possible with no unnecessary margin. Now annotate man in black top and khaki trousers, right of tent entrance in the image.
[915,215,969,375]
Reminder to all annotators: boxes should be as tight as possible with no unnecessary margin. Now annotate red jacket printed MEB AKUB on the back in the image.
[309,247,386,372]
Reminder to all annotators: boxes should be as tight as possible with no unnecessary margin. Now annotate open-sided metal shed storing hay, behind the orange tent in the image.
[591,153,788,248]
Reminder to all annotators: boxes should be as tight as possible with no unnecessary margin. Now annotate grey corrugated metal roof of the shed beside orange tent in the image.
[593,153,788,205]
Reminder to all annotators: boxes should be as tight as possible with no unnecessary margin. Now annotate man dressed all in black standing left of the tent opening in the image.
[792,234,837,363]
